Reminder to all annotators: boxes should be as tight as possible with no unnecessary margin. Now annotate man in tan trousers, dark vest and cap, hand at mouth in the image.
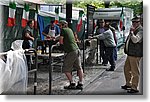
[121,16,143,93]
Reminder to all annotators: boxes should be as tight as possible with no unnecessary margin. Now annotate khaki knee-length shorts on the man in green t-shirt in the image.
[63,49,82,72]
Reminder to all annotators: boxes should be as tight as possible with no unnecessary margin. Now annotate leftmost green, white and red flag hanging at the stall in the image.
[7,2,16,27]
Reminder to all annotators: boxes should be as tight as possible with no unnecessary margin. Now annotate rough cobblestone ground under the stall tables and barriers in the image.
[27,49,123,95]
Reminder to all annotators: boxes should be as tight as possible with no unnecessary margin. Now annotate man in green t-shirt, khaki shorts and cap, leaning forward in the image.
[56,20,83,90]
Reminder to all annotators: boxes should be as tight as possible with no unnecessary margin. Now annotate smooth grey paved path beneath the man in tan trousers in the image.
[78,56,143,95]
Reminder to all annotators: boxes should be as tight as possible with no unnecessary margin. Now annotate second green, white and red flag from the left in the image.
[22,4,29,28]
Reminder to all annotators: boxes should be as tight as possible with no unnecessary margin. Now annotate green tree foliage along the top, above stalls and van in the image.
[43,0,143,15]
